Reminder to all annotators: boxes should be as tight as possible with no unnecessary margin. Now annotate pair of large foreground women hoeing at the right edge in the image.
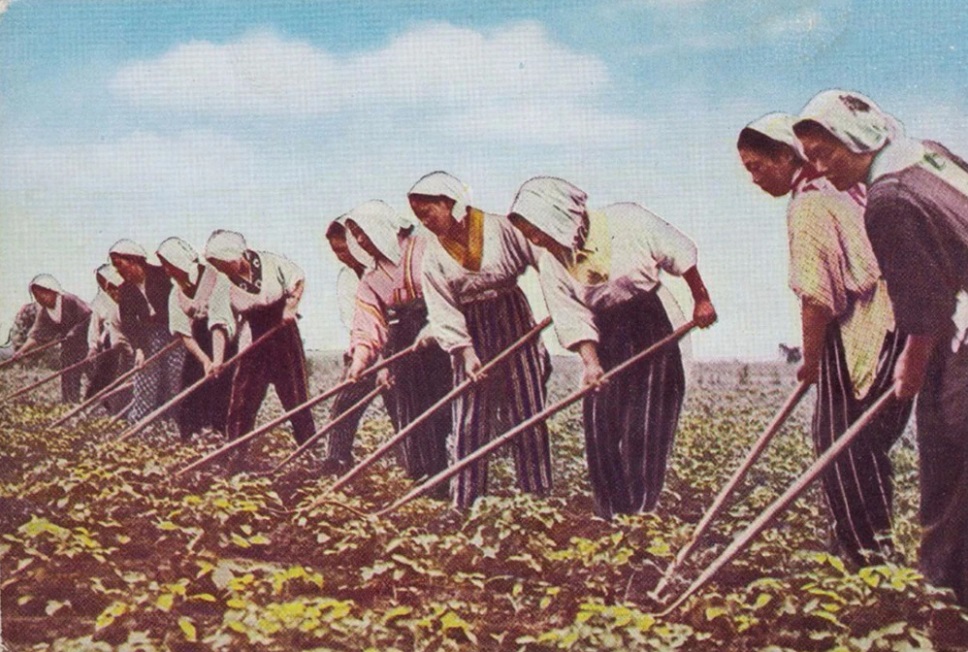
[737,90,968,606]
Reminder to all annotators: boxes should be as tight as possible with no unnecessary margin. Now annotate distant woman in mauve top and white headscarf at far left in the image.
[14,274,91,403]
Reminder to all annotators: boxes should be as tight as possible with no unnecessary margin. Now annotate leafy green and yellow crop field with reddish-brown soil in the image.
[0,356,968,652]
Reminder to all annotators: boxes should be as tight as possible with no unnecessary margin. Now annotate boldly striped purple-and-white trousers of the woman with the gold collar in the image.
[447,288,551,509]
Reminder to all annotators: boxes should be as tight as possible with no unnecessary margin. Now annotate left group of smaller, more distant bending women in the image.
[15,231,314,442]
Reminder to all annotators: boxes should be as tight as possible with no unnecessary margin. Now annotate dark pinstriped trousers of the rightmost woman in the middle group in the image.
[584,292,686,519]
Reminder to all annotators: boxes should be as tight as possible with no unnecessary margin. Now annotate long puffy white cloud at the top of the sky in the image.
[112,23,609,116]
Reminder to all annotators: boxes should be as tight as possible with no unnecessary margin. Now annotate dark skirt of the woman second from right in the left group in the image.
[176,319,238,439]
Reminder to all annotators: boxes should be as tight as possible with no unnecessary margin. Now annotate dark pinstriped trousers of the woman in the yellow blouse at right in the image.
[812,323,911,566]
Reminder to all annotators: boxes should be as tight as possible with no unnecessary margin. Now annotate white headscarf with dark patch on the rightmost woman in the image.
[797,89,903,154]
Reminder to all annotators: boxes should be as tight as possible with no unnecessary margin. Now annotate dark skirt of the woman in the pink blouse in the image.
[383,300,451,479]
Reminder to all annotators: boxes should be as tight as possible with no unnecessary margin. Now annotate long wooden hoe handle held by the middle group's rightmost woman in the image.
[376,321,696,516]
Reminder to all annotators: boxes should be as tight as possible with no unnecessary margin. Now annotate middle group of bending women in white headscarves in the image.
[326,172,716,518]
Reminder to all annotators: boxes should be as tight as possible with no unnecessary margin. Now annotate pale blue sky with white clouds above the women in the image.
[0,0,968,360]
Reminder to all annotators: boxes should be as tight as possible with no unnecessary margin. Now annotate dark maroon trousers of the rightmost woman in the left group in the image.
[226,301,315,444]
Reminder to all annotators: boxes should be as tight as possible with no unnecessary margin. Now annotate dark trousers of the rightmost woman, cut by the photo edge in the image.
[917,326,968,607]
